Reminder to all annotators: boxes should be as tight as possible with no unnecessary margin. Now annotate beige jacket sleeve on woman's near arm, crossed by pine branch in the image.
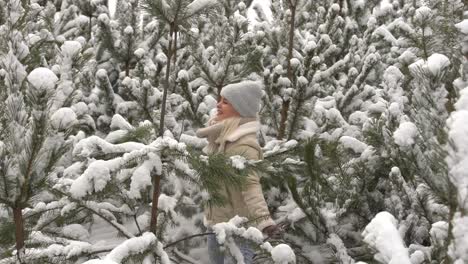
[229,145,275,231]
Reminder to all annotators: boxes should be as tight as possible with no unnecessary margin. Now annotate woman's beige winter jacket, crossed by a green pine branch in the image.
[197,121,275,230]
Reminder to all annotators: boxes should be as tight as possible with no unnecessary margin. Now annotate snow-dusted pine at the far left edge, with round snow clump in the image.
[0,1,75,263]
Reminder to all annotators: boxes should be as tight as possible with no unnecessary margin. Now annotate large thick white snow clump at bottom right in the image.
[362,212,411,264]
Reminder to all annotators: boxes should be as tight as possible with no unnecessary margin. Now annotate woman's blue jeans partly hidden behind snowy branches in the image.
[207,234,255,264]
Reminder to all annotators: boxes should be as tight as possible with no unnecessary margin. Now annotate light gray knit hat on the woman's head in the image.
[221,81,262,117]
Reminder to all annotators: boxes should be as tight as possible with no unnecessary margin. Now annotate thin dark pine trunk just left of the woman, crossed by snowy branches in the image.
[150,23,174,235]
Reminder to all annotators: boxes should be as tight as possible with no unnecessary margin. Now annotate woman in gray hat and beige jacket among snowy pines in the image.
[197,81,278,264]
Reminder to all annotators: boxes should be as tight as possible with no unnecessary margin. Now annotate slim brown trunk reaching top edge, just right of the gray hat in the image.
[276,0,296,139]
